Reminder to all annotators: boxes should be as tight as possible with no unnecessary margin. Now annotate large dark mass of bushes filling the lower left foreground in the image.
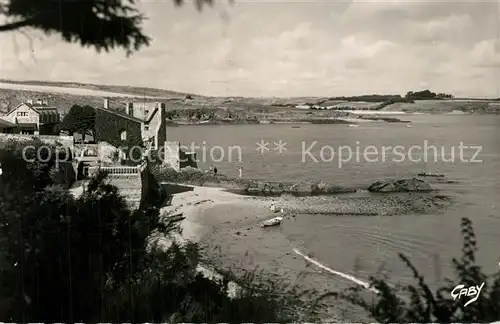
[0,143,306,322]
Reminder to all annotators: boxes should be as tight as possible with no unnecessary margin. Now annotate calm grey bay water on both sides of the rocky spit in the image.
[168,114,500,292]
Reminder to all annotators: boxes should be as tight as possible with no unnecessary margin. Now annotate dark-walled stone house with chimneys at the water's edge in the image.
[62,99,197,170]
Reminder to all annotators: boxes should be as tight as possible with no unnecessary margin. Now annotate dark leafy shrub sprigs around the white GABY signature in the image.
[340,218,500,323]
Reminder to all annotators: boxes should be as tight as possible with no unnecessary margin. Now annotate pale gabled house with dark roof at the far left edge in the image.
[0,100,61,135]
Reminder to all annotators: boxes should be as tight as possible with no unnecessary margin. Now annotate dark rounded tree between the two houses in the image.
[61,105,96,143]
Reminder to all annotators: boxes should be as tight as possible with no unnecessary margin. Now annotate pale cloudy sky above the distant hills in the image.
[0,0,500,97]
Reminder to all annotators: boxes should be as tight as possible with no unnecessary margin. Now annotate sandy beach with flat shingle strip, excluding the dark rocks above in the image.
[154,185,452,321]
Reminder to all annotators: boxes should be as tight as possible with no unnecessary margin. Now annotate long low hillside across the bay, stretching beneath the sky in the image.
[0,80,500,118]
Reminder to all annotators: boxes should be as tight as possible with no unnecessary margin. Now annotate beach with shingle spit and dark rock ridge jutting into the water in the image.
[151,166,453,321]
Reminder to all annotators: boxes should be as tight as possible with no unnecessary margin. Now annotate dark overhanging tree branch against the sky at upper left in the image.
[0,0,219,55]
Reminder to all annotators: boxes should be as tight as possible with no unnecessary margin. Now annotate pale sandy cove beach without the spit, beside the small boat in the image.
[156,186,378,320]
